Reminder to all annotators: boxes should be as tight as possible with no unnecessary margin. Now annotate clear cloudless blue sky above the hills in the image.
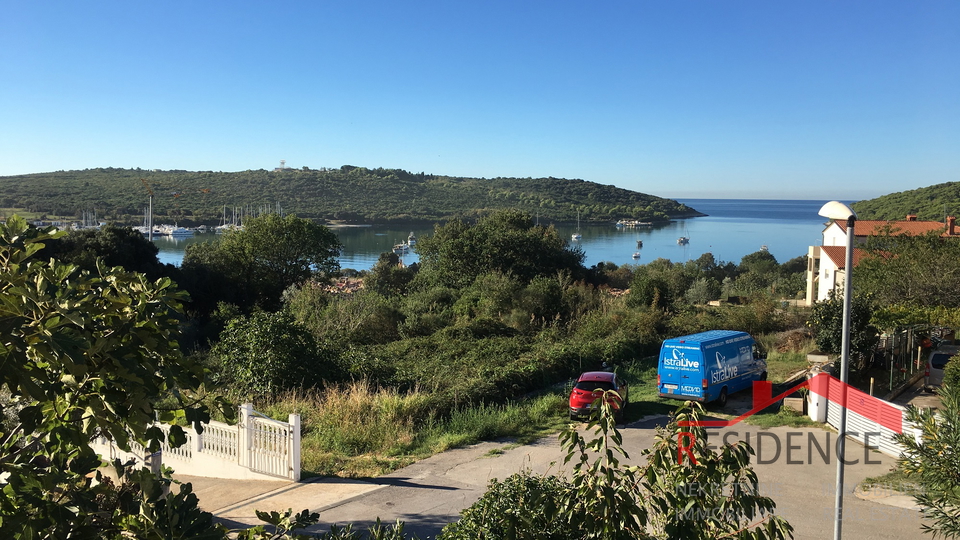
[0,0,960,200]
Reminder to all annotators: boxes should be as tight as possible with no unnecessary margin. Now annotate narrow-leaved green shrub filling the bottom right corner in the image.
[896,386,960,538]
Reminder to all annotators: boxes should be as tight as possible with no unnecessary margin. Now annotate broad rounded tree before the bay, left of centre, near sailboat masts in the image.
[182,214,342,311]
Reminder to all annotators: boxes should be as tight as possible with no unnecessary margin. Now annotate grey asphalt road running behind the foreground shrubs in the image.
[302,417,924,540]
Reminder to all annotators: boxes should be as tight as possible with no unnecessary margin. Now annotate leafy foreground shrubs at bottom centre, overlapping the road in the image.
[440,395,793,540]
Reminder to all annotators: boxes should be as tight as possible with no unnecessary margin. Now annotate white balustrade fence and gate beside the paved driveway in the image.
[94,403,300,482]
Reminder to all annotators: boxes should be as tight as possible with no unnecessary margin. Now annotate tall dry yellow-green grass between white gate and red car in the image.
[261,382,566,477]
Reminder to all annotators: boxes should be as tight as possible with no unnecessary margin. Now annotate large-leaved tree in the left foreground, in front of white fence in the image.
[0,216,230,538]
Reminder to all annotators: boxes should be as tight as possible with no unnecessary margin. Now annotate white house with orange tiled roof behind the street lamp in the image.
[806,215,960,306]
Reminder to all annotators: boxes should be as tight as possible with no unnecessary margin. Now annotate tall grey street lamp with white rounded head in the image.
[820,201,857,540]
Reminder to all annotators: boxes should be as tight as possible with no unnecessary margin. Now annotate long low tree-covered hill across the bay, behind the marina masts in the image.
[0,165,696,226]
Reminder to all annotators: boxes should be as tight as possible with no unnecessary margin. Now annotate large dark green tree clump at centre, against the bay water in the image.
[414,210,586,288]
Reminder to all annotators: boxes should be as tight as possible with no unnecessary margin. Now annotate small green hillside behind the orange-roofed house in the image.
[853,182,960,221]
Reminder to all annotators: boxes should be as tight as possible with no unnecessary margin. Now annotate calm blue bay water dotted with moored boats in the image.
[154,199,848,270]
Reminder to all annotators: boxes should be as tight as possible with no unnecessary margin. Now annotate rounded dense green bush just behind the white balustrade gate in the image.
[211,312,340,396]
